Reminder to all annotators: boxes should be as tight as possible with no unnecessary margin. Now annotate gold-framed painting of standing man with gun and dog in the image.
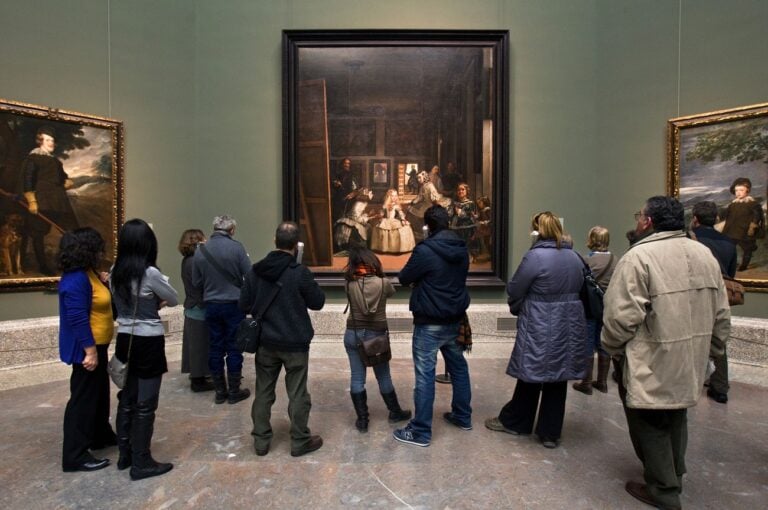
[0,99,124,291]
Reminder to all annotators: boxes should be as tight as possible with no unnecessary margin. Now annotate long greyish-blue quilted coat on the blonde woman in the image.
[507,241,587,382]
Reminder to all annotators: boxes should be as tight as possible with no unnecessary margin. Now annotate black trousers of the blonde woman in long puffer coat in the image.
[499,379,568,439]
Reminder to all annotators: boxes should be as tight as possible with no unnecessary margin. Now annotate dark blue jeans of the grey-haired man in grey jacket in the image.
[205,301,245,374]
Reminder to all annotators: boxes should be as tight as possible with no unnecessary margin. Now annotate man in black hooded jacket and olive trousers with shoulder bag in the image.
[239,222,325,457]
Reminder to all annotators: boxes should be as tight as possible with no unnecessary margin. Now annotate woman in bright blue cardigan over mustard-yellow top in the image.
[58,228,116,471]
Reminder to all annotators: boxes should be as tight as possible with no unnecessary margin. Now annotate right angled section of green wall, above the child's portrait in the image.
[594,0,768,317]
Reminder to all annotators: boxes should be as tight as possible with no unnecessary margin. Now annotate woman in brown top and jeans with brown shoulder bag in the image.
[344,247,411,432]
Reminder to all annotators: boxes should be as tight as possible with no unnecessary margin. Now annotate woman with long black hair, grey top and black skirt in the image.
[111,219,178,480]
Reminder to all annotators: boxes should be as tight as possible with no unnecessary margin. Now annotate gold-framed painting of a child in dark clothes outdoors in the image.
[667,103,768,292]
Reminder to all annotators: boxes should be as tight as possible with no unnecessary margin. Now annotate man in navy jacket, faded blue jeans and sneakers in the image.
[393,205,472,446]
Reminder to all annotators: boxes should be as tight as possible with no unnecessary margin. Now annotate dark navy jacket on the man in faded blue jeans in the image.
[398,230,469,324]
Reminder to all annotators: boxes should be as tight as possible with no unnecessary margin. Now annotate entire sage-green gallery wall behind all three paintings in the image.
[0,0,768,320]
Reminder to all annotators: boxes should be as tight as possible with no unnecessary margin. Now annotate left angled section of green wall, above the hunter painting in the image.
[0,0,199,320]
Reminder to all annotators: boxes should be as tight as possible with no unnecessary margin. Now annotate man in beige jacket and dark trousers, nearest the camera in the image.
[601,196,731,508]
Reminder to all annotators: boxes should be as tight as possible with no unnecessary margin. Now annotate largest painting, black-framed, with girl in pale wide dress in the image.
[283,30,509,286]
